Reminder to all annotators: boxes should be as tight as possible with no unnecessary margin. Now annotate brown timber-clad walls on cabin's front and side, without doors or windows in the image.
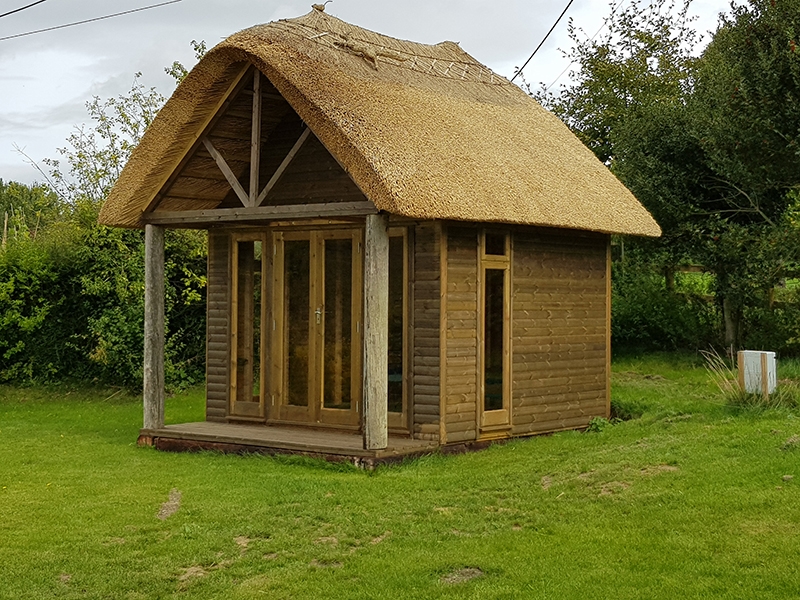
[198,223,609,444]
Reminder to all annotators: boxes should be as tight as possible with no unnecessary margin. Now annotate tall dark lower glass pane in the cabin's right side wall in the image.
[483,269,505,410]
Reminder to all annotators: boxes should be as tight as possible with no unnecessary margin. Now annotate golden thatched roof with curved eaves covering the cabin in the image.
[100,10,660,236]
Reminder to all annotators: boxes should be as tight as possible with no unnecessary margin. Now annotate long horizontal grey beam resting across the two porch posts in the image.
[144,200,378,225]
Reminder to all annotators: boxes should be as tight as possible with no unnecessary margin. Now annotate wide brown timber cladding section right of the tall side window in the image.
[511,228,610,435]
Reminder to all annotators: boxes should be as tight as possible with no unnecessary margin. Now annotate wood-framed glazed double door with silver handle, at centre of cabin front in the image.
[270,230,363,427]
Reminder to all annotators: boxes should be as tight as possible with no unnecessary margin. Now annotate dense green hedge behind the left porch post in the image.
[0,193,206,388]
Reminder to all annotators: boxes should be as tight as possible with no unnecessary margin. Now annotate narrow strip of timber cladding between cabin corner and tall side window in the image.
[444,225,479,444]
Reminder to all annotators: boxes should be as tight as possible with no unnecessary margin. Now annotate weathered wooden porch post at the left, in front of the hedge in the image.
[144,225,165,429]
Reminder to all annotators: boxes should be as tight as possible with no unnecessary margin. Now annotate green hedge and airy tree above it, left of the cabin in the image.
[0,52,206,387]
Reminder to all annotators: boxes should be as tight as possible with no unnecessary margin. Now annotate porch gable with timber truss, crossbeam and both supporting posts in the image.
[144,66,389,450]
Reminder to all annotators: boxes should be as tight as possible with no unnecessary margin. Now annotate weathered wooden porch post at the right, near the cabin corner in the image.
[363,214,389,450]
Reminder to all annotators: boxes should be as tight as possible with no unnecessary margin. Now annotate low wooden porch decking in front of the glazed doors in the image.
[139,422,439,468]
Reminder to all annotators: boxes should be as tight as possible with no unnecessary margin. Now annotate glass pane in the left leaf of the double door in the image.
[284,240,311,406]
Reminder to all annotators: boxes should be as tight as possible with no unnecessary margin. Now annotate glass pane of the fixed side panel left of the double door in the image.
[236,241,261,402]
